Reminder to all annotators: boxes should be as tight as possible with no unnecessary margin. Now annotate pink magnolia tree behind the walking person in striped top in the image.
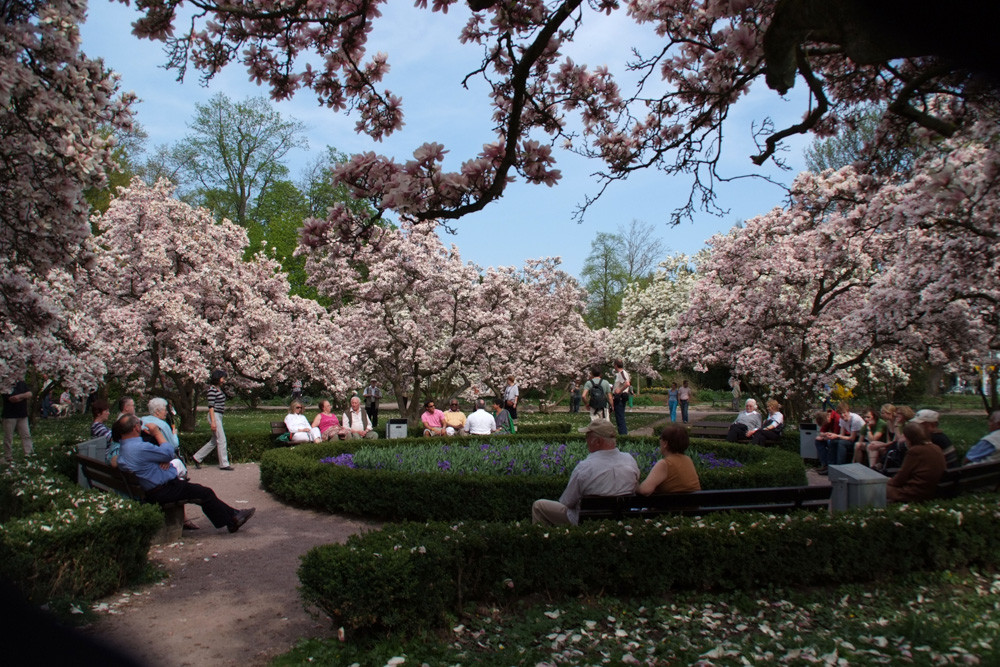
[86,179,357,430]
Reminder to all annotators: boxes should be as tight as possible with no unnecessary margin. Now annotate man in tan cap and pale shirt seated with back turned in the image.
[531,419,639,526]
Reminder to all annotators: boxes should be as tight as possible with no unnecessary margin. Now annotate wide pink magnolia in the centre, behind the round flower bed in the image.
[300,214,596,421]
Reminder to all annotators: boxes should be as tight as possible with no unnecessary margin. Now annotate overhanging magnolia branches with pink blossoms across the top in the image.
[120,0,1000,230]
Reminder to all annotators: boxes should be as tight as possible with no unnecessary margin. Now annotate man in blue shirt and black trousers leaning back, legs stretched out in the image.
[111,415,257,533]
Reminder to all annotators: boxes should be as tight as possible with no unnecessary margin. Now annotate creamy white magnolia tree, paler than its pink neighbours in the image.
[610,251,707,373]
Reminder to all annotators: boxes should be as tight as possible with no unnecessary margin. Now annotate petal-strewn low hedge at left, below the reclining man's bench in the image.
[0,460,163,604]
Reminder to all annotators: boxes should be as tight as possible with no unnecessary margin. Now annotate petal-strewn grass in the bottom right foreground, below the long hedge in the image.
[273,571,1000,667]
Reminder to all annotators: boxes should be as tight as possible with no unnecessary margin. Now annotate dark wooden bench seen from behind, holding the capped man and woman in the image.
[580,486,833,521]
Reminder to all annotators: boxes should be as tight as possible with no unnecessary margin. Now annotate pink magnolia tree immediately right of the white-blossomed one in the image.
[666,168,908,414]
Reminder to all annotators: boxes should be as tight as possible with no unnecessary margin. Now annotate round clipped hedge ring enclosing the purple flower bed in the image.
[260,434,806,521]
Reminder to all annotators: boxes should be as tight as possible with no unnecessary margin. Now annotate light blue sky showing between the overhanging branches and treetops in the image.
[82,0,808,276]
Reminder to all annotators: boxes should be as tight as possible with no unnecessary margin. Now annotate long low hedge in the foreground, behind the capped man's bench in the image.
[299,494,1000,633]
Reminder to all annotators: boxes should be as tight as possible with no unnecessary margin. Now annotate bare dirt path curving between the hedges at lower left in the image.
[84,463,377,667]
